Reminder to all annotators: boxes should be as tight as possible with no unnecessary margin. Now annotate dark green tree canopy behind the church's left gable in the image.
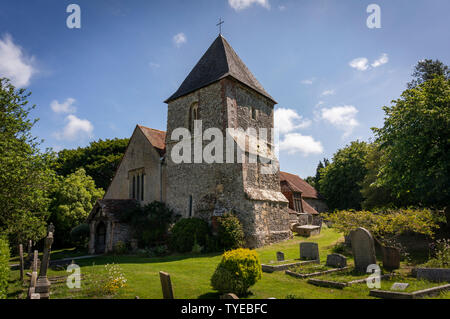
[54,138,129,190]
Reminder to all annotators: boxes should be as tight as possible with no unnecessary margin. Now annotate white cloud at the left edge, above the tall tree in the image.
[0,34,36,87]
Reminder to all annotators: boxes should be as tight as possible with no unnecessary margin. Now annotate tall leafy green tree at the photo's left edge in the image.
[0,78,54,245]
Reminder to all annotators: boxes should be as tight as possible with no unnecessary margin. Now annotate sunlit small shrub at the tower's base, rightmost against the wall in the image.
[217,213,244,250]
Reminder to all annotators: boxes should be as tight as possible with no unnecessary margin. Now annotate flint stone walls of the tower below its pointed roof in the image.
[166,79,292,248]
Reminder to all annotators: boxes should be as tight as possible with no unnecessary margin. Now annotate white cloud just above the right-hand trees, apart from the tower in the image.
[321,105,359,137]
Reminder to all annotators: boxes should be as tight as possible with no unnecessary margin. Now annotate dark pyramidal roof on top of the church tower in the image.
[165,35,276,103]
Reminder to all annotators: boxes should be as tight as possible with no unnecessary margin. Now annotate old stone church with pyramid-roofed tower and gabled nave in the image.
[88,35,310,253]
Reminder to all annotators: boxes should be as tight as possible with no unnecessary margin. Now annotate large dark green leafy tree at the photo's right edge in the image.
[373,75,450,207]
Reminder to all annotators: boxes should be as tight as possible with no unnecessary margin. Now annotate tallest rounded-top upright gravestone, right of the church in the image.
[350,227,377,273]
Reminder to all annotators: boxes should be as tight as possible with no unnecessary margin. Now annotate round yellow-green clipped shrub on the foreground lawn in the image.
[211,248,261,296]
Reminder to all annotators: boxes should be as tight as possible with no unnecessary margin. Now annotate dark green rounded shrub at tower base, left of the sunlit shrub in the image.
[170,218,209,253]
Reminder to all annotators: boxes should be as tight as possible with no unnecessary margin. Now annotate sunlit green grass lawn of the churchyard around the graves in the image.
[9,228,448,299]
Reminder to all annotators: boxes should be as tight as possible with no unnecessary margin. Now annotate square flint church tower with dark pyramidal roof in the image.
[165,35,296,248]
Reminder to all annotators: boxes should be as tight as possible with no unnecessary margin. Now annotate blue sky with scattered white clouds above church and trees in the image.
[0,0,450,177]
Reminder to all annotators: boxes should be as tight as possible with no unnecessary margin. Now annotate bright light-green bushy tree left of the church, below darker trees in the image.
[50,168,104,245]
